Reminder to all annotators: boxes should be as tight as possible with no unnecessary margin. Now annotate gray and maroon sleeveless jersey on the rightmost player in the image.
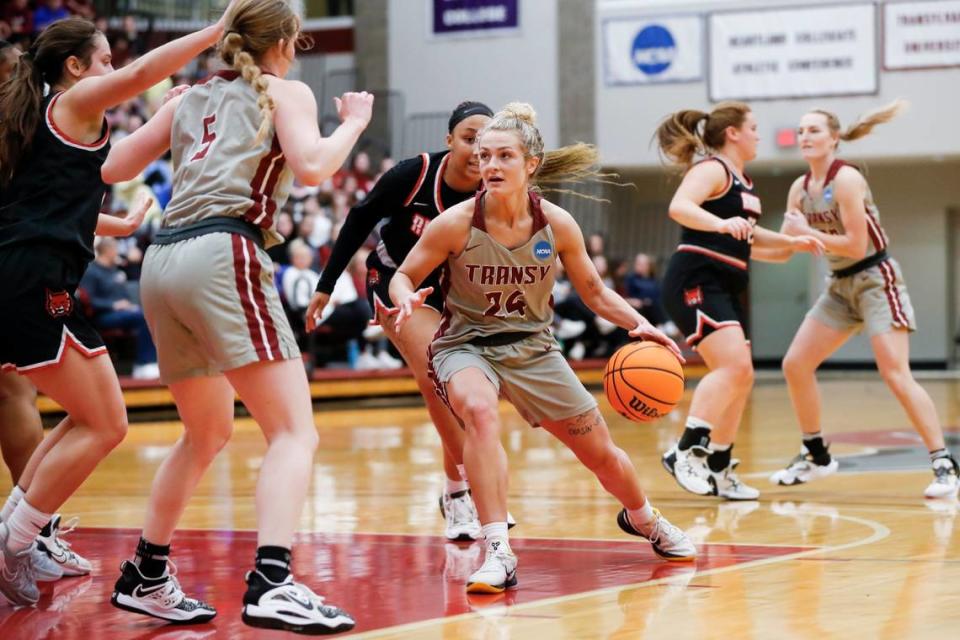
[800,160,887,271]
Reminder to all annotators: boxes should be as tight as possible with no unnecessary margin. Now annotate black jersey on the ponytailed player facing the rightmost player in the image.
[677,156,761,271]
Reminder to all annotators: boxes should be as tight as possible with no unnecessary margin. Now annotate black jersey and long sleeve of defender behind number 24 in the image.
[317,151,475,293]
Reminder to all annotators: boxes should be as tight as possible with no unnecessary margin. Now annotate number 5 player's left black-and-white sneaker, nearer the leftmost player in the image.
[110,560,217,624]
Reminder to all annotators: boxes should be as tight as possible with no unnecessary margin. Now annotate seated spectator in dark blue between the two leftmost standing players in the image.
[80,237,160,379]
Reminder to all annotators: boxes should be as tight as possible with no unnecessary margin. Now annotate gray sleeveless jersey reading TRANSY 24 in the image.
[432,191,557,352]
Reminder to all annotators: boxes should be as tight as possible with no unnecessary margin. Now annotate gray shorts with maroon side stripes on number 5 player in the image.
[140,232,300,383]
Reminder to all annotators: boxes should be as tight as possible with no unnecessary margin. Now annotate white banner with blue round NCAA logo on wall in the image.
[601,15,704,86]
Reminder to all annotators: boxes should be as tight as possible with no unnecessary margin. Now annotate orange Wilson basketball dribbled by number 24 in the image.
[603,342,683,422]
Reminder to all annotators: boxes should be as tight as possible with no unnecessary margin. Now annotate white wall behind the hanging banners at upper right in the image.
[595,0,960,167]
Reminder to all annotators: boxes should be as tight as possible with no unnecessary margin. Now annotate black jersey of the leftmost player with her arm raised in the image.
[0,93,110,263]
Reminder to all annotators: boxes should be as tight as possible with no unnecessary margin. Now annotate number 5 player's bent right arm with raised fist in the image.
[270,80,373,186]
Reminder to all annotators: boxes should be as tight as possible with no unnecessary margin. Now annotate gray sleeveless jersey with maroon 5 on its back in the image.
[163,71,293,247]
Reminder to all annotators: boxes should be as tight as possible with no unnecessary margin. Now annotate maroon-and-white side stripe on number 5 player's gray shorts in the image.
[230,234,283,360]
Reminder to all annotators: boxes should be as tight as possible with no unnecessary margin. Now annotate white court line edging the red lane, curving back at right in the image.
[351,514,890,638]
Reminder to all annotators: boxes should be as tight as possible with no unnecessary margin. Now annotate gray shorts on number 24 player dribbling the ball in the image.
[430,332,597,427]
